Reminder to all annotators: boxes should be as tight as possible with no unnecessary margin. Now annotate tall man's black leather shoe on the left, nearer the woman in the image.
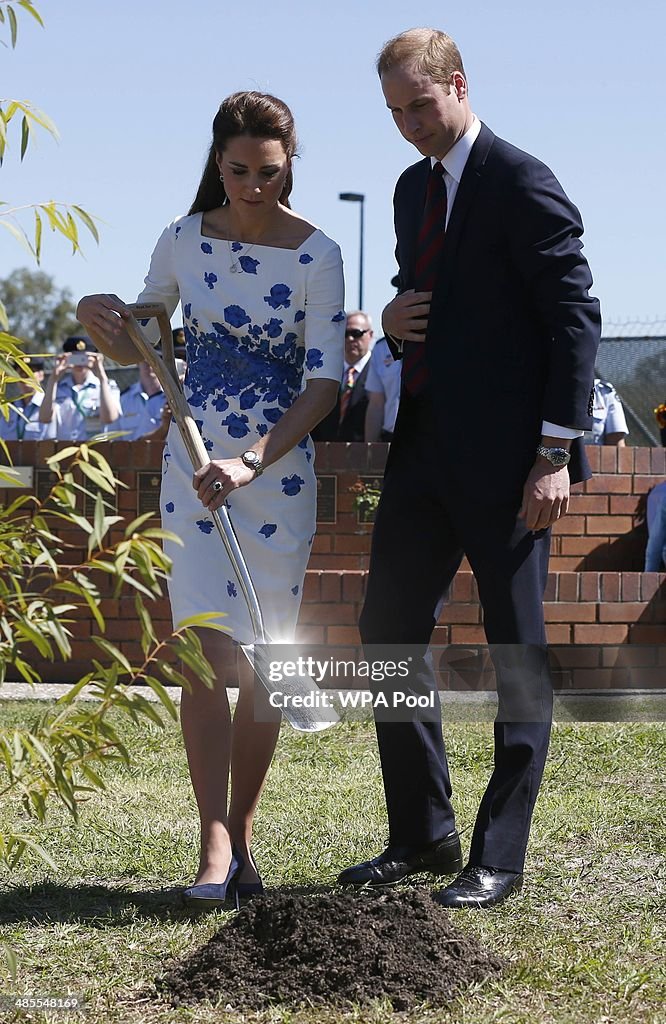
[337,831,462,886]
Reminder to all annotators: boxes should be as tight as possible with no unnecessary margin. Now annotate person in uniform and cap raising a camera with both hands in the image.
[39,336,122,441]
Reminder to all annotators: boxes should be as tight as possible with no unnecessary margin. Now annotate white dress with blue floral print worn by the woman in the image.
[137,213,345,643]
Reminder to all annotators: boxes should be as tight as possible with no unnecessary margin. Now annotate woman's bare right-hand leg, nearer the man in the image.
[228,651,280,882]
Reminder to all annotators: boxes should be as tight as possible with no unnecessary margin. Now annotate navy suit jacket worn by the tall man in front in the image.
[391,124,600,492]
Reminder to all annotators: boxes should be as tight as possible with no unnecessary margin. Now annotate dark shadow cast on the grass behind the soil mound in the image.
[0,882,333,928]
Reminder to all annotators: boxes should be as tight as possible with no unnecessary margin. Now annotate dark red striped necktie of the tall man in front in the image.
[403,161,447,395]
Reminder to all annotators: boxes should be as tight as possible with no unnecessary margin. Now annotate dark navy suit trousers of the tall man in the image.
[360,397,552,871]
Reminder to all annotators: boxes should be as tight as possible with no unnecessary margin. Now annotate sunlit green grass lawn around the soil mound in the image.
[0,702,666,1024]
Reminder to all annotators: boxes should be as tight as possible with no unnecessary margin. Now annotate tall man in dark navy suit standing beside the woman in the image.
[339,29,600,907]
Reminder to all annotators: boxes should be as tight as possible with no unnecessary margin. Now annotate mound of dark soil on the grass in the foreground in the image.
[156,889,503,1010]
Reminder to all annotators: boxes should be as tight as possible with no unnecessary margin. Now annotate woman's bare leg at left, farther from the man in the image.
[180,630,236,885]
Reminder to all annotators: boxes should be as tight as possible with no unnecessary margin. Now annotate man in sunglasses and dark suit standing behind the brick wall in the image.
[313,310,374,441]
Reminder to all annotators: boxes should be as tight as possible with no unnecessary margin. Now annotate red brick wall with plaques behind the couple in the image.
[0,441,666,686]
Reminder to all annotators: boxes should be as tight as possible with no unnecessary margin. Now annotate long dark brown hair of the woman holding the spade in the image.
[190,92,297,214]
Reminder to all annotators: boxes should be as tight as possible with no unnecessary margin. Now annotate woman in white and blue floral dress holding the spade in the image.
[78,92,345,906]
